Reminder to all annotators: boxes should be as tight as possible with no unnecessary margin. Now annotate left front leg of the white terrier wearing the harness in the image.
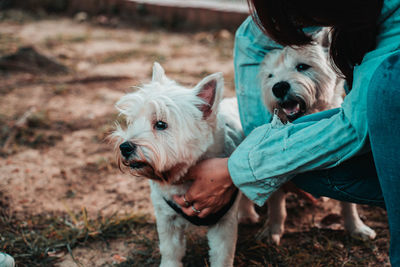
[156,215,186,267]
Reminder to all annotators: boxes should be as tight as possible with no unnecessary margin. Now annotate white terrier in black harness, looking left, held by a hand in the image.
[113,63,258,267]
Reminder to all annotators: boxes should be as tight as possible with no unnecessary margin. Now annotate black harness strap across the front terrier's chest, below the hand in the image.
[164,190,239,226]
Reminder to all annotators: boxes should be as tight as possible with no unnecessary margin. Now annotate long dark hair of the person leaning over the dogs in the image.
[247,0,383,88]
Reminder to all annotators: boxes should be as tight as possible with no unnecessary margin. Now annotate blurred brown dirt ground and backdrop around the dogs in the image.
[0,0,389,267]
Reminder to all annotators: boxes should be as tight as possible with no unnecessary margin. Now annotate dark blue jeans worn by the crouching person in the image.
[292,52,400,266]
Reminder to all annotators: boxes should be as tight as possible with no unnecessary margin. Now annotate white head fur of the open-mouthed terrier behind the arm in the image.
[261,44,343,122]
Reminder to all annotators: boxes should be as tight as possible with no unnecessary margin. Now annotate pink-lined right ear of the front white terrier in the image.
[194,72,224,119]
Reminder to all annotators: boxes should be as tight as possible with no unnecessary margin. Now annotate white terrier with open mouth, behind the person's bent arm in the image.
[260,41,376,244]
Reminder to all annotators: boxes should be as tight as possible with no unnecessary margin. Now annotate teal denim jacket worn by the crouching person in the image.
[228,0,400,206]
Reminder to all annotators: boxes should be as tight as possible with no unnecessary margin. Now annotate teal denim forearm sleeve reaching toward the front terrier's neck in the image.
[228,109,360,206]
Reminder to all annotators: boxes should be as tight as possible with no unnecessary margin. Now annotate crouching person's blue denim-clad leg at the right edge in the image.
[367,52,400,266]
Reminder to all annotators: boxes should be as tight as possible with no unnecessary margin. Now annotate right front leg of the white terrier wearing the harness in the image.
[207,210,238,267]
